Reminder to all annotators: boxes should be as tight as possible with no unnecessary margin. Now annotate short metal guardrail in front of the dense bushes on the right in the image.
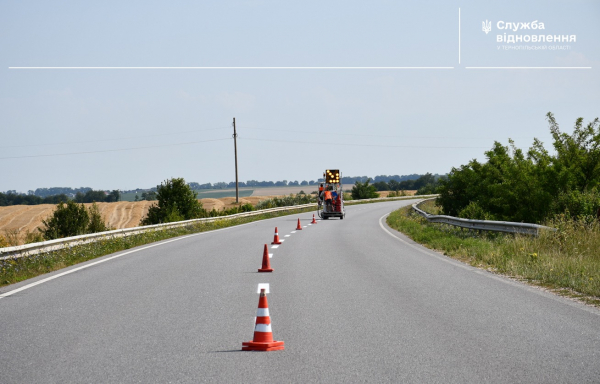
[412,199,556,236]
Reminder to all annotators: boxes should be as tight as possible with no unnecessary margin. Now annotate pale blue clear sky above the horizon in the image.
[0,0,600,192]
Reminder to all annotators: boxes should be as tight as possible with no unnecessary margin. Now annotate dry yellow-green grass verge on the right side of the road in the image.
[387,201,600,307]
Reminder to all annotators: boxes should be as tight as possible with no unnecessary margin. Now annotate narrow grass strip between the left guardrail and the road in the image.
[0,208,315,287]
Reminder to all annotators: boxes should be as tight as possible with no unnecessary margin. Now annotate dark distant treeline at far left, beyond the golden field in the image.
[0,188,121,207]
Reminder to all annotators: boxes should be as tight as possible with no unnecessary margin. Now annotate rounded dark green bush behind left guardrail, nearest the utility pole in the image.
[141,178,207,225]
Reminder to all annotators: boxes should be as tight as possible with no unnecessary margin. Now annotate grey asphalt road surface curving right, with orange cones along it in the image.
[0,201,600,383]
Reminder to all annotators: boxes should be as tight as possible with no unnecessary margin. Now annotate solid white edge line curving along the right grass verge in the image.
[379,213,600,316]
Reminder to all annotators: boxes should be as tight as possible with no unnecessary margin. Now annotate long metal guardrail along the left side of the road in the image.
[0,203,317,260]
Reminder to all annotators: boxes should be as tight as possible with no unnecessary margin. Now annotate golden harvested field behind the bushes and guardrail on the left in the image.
[0,196,282,244]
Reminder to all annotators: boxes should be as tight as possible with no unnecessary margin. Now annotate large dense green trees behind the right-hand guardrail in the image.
[438,112,600,223]
